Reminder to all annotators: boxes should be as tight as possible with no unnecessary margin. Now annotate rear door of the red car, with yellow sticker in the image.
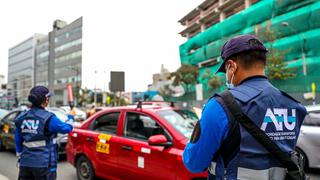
[86,111,121,178]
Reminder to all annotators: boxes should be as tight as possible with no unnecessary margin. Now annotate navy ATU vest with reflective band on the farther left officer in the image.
[15,108,58,168]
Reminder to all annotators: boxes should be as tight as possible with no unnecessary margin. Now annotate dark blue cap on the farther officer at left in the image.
[28,86,53,105]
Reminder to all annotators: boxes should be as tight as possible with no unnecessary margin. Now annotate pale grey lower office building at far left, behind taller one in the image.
[7,34,44,103]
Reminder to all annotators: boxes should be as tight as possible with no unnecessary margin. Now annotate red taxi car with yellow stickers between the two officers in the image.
[66,104,207,180]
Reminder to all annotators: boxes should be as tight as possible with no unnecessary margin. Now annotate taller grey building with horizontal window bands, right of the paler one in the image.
[35,17,82,106]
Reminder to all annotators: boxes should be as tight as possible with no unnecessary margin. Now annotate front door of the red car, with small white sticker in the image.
[118,112,177,179]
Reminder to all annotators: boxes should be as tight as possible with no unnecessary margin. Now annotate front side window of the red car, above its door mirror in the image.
[124,112,171,140]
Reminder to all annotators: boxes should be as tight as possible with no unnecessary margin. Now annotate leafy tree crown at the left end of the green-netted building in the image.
[171,64,199,92]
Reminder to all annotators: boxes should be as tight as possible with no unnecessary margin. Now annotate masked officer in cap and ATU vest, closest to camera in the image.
[183,35,306,180]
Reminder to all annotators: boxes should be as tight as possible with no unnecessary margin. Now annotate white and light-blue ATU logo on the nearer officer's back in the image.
[261,108,296,131]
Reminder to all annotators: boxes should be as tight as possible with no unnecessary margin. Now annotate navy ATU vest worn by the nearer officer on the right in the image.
[209,77,306,179]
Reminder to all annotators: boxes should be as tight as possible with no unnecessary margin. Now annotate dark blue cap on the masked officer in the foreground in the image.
[217,34,268,72]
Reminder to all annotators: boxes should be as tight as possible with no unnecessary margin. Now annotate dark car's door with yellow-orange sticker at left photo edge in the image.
[2,111,20,149]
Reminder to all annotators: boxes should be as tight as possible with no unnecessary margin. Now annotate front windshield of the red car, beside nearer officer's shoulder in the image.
[158,110,198,139]
